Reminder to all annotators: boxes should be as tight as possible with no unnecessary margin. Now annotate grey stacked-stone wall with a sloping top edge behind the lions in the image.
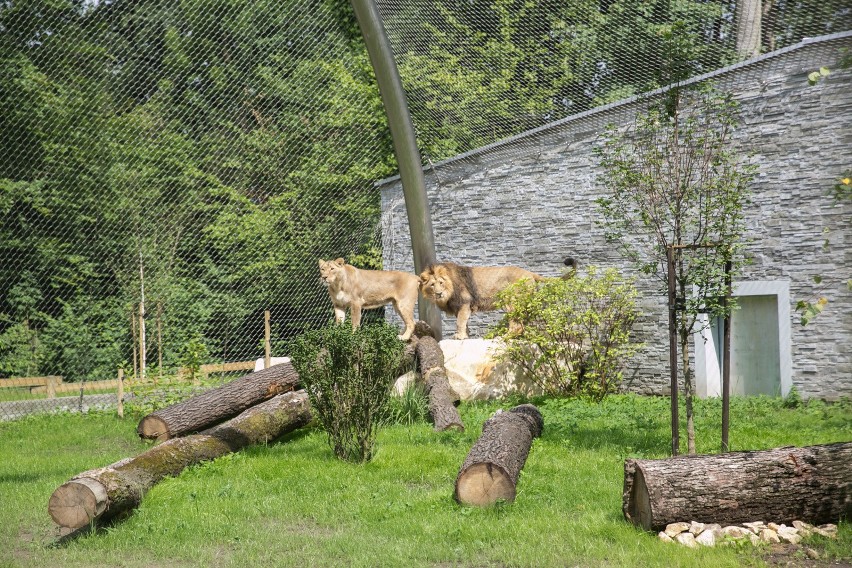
[379,33,852,399]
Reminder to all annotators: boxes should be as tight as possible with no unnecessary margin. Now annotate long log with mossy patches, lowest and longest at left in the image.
[48,391,311,529]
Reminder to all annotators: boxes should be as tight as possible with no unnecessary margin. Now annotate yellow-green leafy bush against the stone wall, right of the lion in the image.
[491,266,639,401]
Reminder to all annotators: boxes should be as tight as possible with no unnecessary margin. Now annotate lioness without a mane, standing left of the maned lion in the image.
[319,258,420,341]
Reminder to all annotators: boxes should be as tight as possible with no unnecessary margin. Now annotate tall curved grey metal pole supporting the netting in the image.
[351,0,441,338]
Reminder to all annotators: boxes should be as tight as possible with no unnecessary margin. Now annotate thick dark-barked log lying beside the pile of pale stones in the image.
[622,442,852,530]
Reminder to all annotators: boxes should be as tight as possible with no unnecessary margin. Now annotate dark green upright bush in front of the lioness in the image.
[290,322,404,463]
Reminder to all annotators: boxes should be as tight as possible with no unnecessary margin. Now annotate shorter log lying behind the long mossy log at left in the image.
[136,363,299,440]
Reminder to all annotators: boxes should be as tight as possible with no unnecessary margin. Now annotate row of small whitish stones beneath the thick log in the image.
[658,521,837,548]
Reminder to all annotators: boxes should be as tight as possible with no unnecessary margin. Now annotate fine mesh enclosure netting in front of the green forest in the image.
[0,0,852,417]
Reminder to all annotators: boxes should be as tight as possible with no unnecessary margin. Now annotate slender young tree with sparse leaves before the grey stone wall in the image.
[597,88,756,453]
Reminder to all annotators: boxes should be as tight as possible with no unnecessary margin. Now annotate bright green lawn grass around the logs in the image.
[0,396,852,568]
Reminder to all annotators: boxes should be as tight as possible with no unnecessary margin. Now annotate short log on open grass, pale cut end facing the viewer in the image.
[455,404,544,505]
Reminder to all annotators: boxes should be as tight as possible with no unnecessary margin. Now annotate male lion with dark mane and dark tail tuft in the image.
[420,257,577,339]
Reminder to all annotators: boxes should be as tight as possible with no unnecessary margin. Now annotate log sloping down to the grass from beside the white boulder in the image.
[415,336,464,432]
